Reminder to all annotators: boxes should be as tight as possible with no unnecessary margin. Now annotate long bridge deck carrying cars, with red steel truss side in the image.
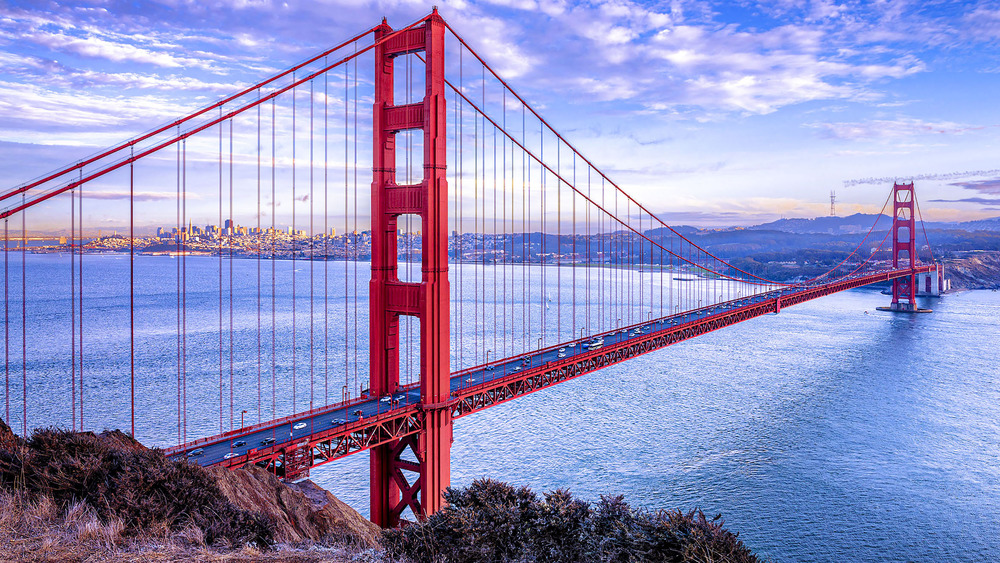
[166,266,935,477]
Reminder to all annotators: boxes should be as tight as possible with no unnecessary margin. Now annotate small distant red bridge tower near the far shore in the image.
[888,182,919,312]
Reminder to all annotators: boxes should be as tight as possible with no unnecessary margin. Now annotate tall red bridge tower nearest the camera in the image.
[369,9,452,527]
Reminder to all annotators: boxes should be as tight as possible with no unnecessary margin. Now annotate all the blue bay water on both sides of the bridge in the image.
[0,252,1000,562]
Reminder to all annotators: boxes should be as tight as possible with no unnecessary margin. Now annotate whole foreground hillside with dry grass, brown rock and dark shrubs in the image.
[0,421,757,563]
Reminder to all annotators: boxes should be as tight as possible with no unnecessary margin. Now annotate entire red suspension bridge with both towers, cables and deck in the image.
[0,11,943,526]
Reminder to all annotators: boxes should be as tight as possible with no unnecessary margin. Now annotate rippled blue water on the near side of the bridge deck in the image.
[312,289,1000,562]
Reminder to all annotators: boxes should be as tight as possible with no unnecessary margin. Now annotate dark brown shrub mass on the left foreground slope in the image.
[0,422,272,547]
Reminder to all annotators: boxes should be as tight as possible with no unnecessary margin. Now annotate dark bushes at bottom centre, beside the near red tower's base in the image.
[383,479,758,563]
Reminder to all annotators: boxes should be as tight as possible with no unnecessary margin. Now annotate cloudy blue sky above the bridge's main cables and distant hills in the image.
[0,0,1000,226]
